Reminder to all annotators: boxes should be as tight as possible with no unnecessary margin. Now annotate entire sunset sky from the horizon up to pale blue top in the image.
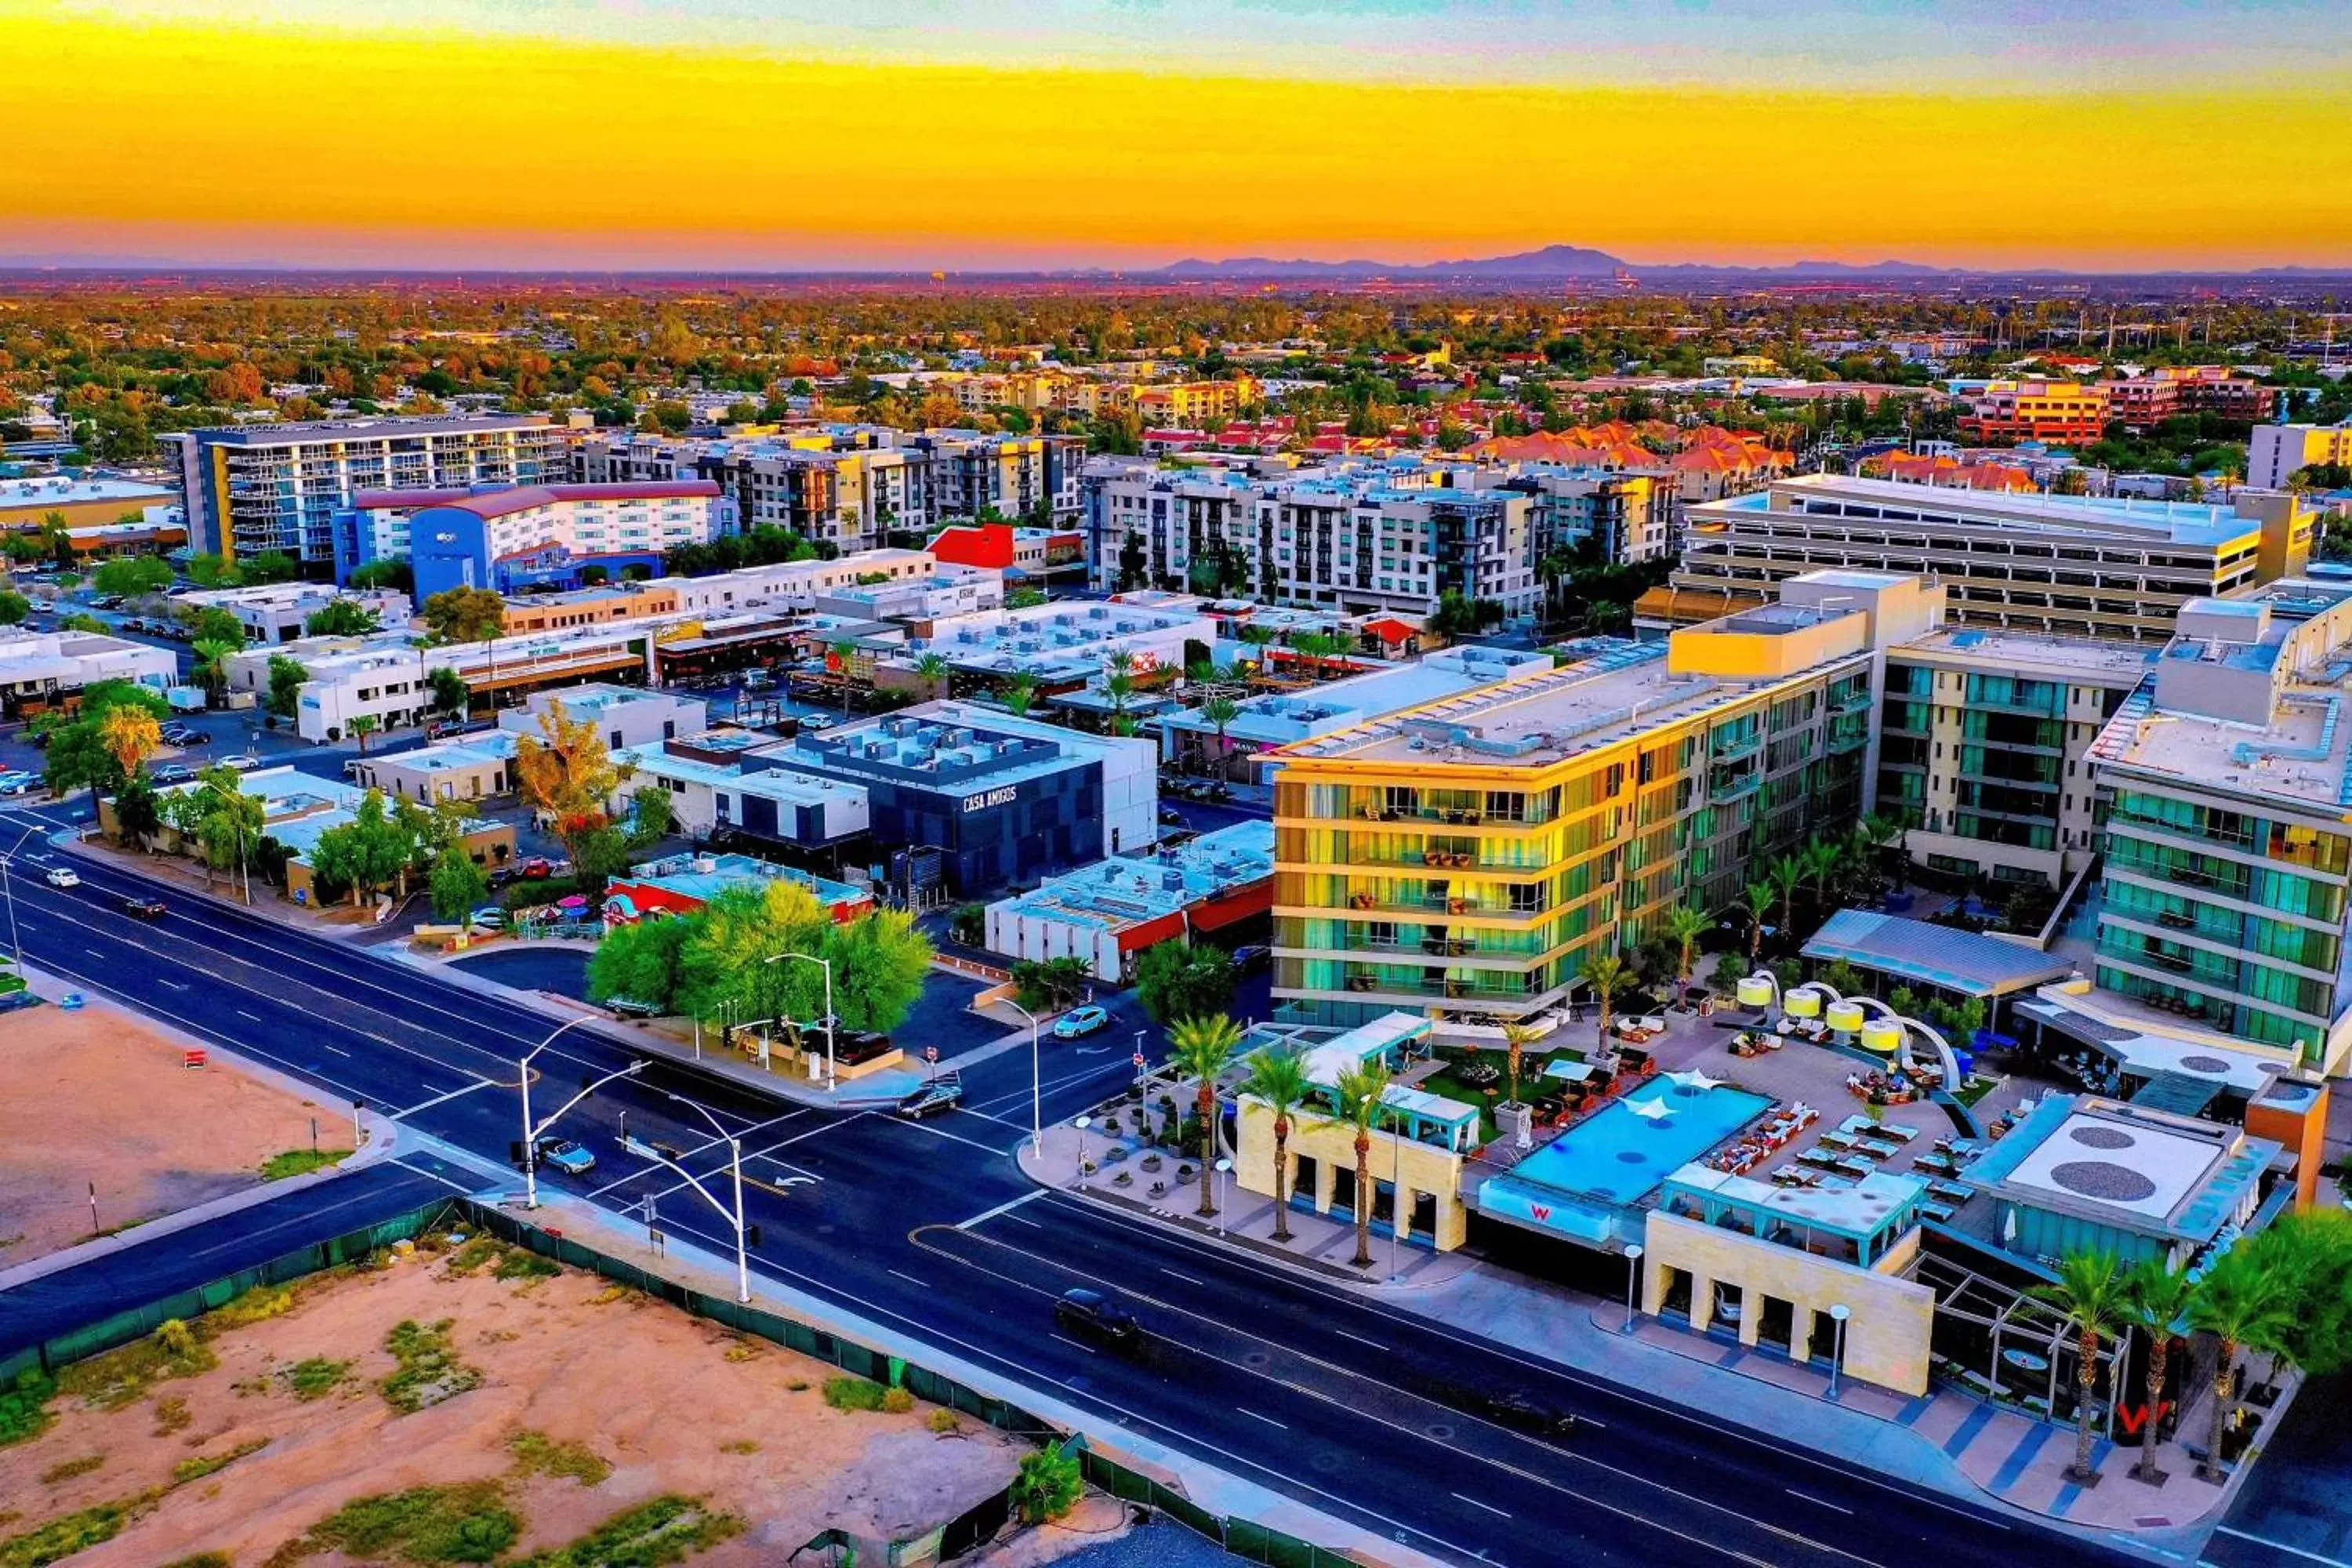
[0,0,2352,270]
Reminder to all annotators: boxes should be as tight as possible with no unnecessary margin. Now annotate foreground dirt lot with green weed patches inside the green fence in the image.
[0,1241,1023,1568]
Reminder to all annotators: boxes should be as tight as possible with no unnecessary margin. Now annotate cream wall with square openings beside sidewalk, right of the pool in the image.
[1642,1208,1936,1394]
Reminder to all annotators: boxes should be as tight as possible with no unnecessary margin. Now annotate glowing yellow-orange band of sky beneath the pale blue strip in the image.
[0,0,2352,270]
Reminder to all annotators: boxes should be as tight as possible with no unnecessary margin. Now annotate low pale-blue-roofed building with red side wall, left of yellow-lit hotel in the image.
[988,822,1275,985]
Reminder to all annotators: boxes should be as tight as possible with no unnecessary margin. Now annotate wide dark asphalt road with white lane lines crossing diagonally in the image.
[0,804,2129,1568]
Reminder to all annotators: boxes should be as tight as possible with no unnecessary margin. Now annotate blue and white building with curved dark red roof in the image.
[334,480,720,600]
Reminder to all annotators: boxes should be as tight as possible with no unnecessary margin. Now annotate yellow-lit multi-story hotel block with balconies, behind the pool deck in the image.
[1272,572,1943,1032]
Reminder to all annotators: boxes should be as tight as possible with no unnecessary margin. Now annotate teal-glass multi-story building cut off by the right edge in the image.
[2091,583,2352,1074]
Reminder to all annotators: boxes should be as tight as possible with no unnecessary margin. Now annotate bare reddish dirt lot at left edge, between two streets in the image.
[0,1001,336,1267]
